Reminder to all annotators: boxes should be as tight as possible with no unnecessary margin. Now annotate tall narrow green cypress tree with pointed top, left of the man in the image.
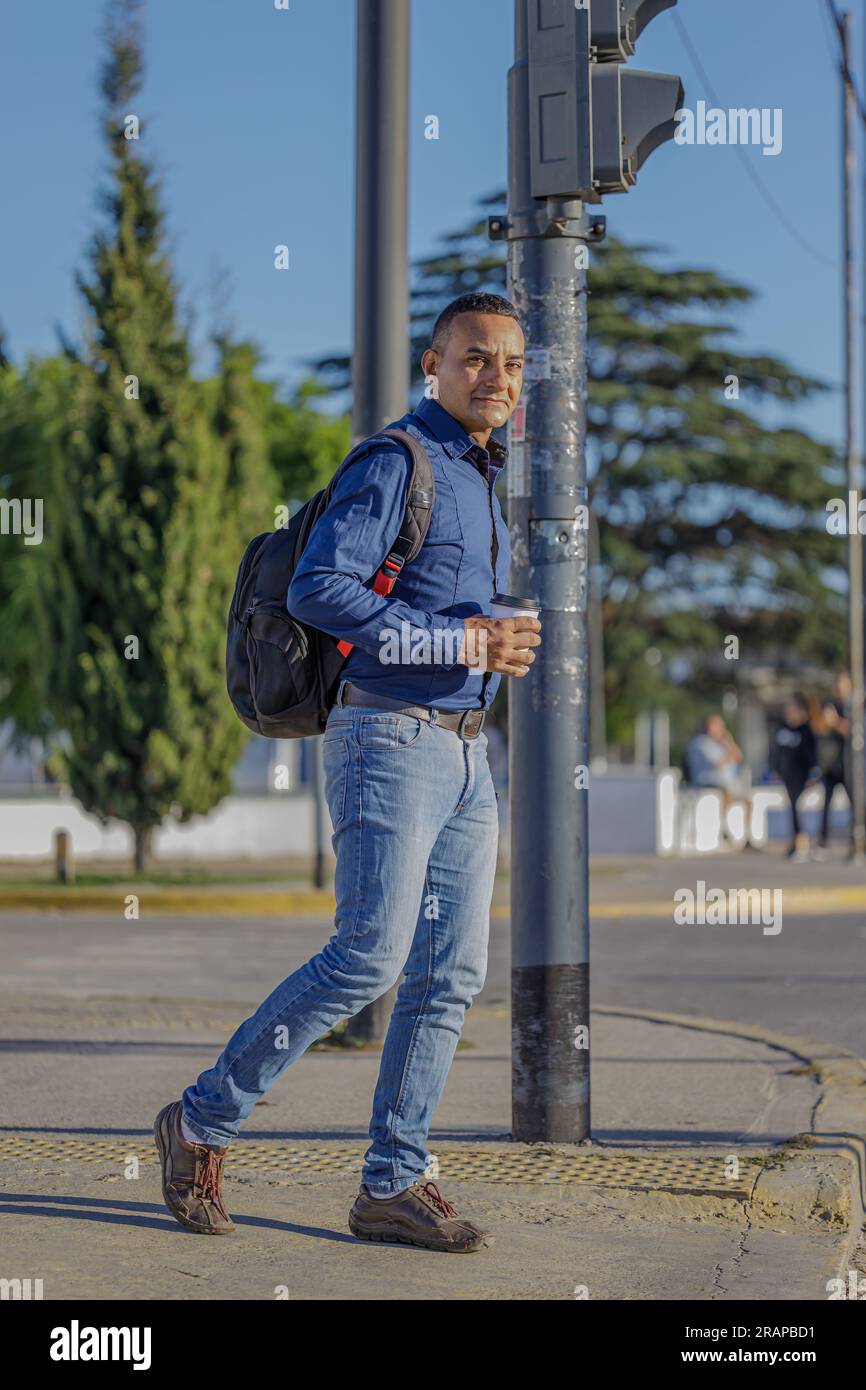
[54,0,267,869]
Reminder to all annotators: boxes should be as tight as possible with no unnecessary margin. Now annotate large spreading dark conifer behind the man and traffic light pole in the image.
[313,193,845,739]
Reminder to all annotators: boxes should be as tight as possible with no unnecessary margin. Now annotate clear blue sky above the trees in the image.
[0,0,866,439]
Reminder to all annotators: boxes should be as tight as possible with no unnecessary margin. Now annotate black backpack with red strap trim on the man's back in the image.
[225,430,435,738]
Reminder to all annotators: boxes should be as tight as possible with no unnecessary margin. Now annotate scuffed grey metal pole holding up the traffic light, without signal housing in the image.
[491,0,603,1143]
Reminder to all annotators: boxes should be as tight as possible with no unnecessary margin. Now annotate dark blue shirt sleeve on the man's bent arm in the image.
[286,449,464,667]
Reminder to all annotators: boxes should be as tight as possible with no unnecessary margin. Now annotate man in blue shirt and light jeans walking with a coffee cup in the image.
[156,293,541,1252]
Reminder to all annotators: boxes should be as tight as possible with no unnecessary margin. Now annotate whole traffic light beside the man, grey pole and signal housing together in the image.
[489,0,683,1144]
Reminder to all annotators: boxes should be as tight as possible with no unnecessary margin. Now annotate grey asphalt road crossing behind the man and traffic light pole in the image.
[0,859,866,1055]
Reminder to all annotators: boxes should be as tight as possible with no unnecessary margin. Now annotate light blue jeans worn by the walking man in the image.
[182,705,499,1195]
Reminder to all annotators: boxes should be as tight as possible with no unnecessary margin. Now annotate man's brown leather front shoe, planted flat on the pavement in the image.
[349,1183,493,1254]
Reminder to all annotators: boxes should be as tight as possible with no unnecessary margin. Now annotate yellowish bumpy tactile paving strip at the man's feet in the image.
[0,1134,762,1201]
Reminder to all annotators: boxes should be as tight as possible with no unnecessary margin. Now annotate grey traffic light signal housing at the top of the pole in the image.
[521,0,684,203]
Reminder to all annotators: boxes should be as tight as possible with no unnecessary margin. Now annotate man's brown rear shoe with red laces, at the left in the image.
[153,1101,238,1236]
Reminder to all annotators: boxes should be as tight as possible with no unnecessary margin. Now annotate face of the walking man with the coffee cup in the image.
[421,314,524,434]
